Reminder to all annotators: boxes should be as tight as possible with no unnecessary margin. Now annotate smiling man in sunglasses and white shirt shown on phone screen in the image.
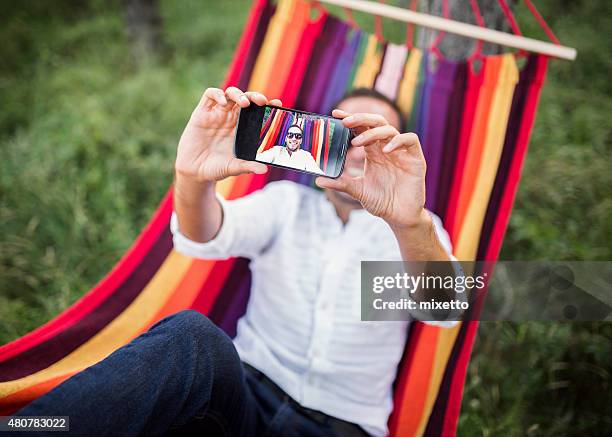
[257,124,323,174]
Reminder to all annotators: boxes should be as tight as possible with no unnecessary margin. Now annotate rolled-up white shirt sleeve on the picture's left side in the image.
[170,181,299,259]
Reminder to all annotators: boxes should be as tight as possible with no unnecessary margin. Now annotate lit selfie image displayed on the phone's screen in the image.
[255,107,346,175]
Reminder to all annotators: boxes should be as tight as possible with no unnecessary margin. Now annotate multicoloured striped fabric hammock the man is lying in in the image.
[0,0,547,436]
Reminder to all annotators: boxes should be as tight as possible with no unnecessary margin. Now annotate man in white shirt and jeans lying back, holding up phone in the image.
[19,87,450,437]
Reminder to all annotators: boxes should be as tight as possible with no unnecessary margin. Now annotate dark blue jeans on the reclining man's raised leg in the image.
[17,311,350,437]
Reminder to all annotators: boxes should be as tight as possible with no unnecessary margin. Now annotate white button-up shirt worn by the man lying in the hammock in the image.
[172,181,451,436]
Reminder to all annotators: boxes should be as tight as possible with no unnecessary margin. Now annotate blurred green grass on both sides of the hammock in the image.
[0,0,612,436]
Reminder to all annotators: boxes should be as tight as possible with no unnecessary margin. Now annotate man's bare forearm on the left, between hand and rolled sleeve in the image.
[174,174,223,243]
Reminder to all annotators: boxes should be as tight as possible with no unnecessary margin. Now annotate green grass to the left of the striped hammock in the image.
[0,1,248,343]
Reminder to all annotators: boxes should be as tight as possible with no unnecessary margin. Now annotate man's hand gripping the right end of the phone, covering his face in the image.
[316,109,427,228]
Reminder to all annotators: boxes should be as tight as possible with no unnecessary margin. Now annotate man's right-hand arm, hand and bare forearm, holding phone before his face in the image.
[316,110,461,324]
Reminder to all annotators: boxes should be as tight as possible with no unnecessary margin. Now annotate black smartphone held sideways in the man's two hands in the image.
[234,104,353,178]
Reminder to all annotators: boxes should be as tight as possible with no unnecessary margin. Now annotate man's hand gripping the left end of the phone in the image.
[175,87,281,183]
